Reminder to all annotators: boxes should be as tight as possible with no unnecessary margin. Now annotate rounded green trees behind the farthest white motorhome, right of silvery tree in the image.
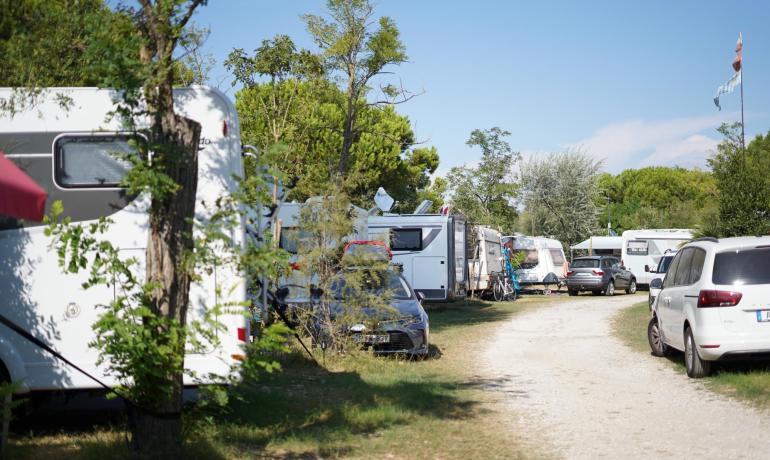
[598,166,717,233]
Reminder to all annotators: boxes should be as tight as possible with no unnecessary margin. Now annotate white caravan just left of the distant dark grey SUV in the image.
[503,235,565,286]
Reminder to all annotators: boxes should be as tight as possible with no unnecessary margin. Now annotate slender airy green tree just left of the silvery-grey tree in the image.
[447,127,520,232]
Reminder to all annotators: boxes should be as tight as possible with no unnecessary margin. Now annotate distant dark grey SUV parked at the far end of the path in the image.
[567,256,636,296]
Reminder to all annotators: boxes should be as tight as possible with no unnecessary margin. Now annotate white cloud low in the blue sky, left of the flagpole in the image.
[566,113,735,172]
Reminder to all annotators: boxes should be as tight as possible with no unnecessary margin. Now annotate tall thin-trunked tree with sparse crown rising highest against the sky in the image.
[303,0,411,174]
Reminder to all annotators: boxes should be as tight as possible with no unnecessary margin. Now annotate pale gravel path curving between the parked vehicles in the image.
[482,296,770,460]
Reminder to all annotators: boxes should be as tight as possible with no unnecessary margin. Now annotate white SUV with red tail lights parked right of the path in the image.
[647,236,770,378]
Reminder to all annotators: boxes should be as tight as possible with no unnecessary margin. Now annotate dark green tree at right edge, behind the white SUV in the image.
[706,123,770,236]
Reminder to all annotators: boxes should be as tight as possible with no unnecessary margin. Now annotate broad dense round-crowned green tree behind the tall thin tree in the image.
[236,80,439,210]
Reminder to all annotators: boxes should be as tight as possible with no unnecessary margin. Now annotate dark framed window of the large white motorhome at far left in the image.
[54,136,137,188]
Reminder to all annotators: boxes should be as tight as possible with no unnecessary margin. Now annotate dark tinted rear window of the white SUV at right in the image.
[711,247,770,285]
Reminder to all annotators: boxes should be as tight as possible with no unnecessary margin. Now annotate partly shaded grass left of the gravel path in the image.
[12,296,566,459]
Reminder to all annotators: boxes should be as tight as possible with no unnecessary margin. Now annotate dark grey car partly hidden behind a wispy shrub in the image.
[318,268,430,356]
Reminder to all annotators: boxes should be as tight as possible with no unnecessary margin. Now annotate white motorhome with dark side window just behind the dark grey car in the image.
[368,214,467,302]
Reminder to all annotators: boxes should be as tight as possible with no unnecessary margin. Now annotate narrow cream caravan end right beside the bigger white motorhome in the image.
[468,225,503,295]
